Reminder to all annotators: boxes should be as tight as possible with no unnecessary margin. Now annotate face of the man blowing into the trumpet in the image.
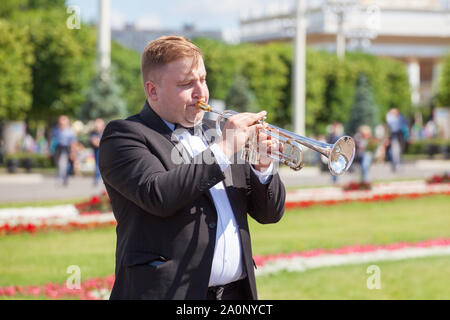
[149,57,209,127]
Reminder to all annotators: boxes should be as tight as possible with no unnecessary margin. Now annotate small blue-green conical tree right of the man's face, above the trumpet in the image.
[225,74,258,112]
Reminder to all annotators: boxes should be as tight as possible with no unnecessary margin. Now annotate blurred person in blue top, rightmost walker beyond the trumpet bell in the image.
[386,108,407,172]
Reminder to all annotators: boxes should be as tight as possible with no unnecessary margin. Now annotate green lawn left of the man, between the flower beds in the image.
[0,227,116,286]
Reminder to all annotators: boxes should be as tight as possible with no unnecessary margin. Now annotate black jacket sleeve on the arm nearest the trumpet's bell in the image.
[246,167,286,224]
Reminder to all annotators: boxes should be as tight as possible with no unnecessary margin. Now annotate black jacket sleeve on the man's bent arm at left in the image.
[99,120,225,217]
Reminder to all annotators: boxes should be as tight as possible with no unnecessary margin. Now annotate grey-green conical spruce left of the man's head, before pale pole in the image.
[79,70,127,121]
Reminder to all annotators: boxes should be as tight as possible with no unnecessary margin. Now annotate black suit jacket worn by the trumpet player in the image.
[99,103,285,299]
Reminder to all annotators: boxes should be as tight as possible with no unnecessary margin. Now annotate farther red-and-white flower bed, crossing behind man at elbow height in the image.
[0,180,450,236]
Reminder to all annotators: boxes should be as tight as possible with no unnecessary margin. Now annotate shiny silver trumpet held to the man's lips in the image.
[196,100,355,176]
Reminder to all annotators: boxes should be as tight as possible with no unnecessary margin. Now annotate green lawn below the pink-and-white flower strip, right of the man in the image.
[256,256,450,300]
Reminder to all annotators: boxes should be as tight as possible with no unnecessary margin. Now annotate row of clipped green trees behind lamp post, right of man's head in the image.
[195,39,411,134]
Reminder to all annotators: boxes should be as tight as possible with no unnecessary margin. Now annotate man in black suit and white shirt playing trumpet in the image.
[99,36,286,299]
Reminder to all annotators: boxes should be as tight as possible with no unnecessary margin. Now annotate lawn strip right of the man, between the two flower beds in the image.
[250,196,450,254]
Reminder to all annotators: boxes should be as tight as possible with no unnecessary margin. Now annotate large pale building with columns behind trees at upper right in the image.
[240,0,450,105]
